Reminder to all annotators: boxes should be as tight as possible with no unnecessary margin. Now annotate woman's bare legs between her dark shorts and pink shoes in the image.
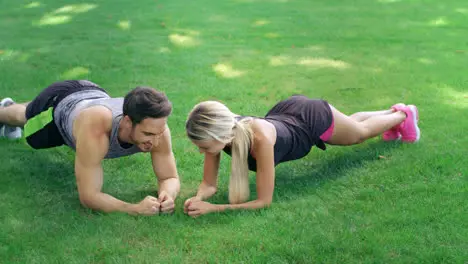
[327,105,406,145]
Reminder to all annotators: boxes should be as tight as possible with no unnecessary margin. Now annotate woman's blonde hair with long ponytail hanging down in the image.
[185,101,253,204]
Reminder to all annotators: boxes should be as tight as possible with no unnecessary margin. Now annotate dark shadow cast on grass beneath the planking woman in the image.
[194,141,401,220]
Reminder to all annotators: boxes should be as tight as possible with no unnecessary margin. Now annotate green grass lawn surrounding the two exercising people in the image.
[0,0,468,263]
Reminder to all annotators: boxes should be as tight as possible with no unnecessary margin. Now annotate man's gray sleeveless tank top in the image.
[54,90,141,159]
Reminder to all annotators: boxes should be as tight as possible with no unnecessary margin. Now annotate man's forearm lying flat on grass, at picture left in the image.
[80,192,138,214]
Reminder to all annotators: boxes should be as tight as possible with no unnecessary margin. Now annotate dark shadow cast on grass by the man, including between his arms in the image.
[0,140,238,227]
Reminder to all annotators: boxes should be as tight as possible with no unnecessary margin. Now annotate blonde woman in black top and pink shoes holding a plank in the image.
[184,95,420,217]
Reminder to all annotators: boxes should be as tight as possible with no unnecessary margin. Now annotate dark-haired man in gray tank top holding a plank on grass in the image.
[0,80,180,215]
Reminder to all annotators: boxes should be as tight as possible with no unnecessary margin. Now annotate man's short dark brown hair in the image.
[123,86,172,125]
